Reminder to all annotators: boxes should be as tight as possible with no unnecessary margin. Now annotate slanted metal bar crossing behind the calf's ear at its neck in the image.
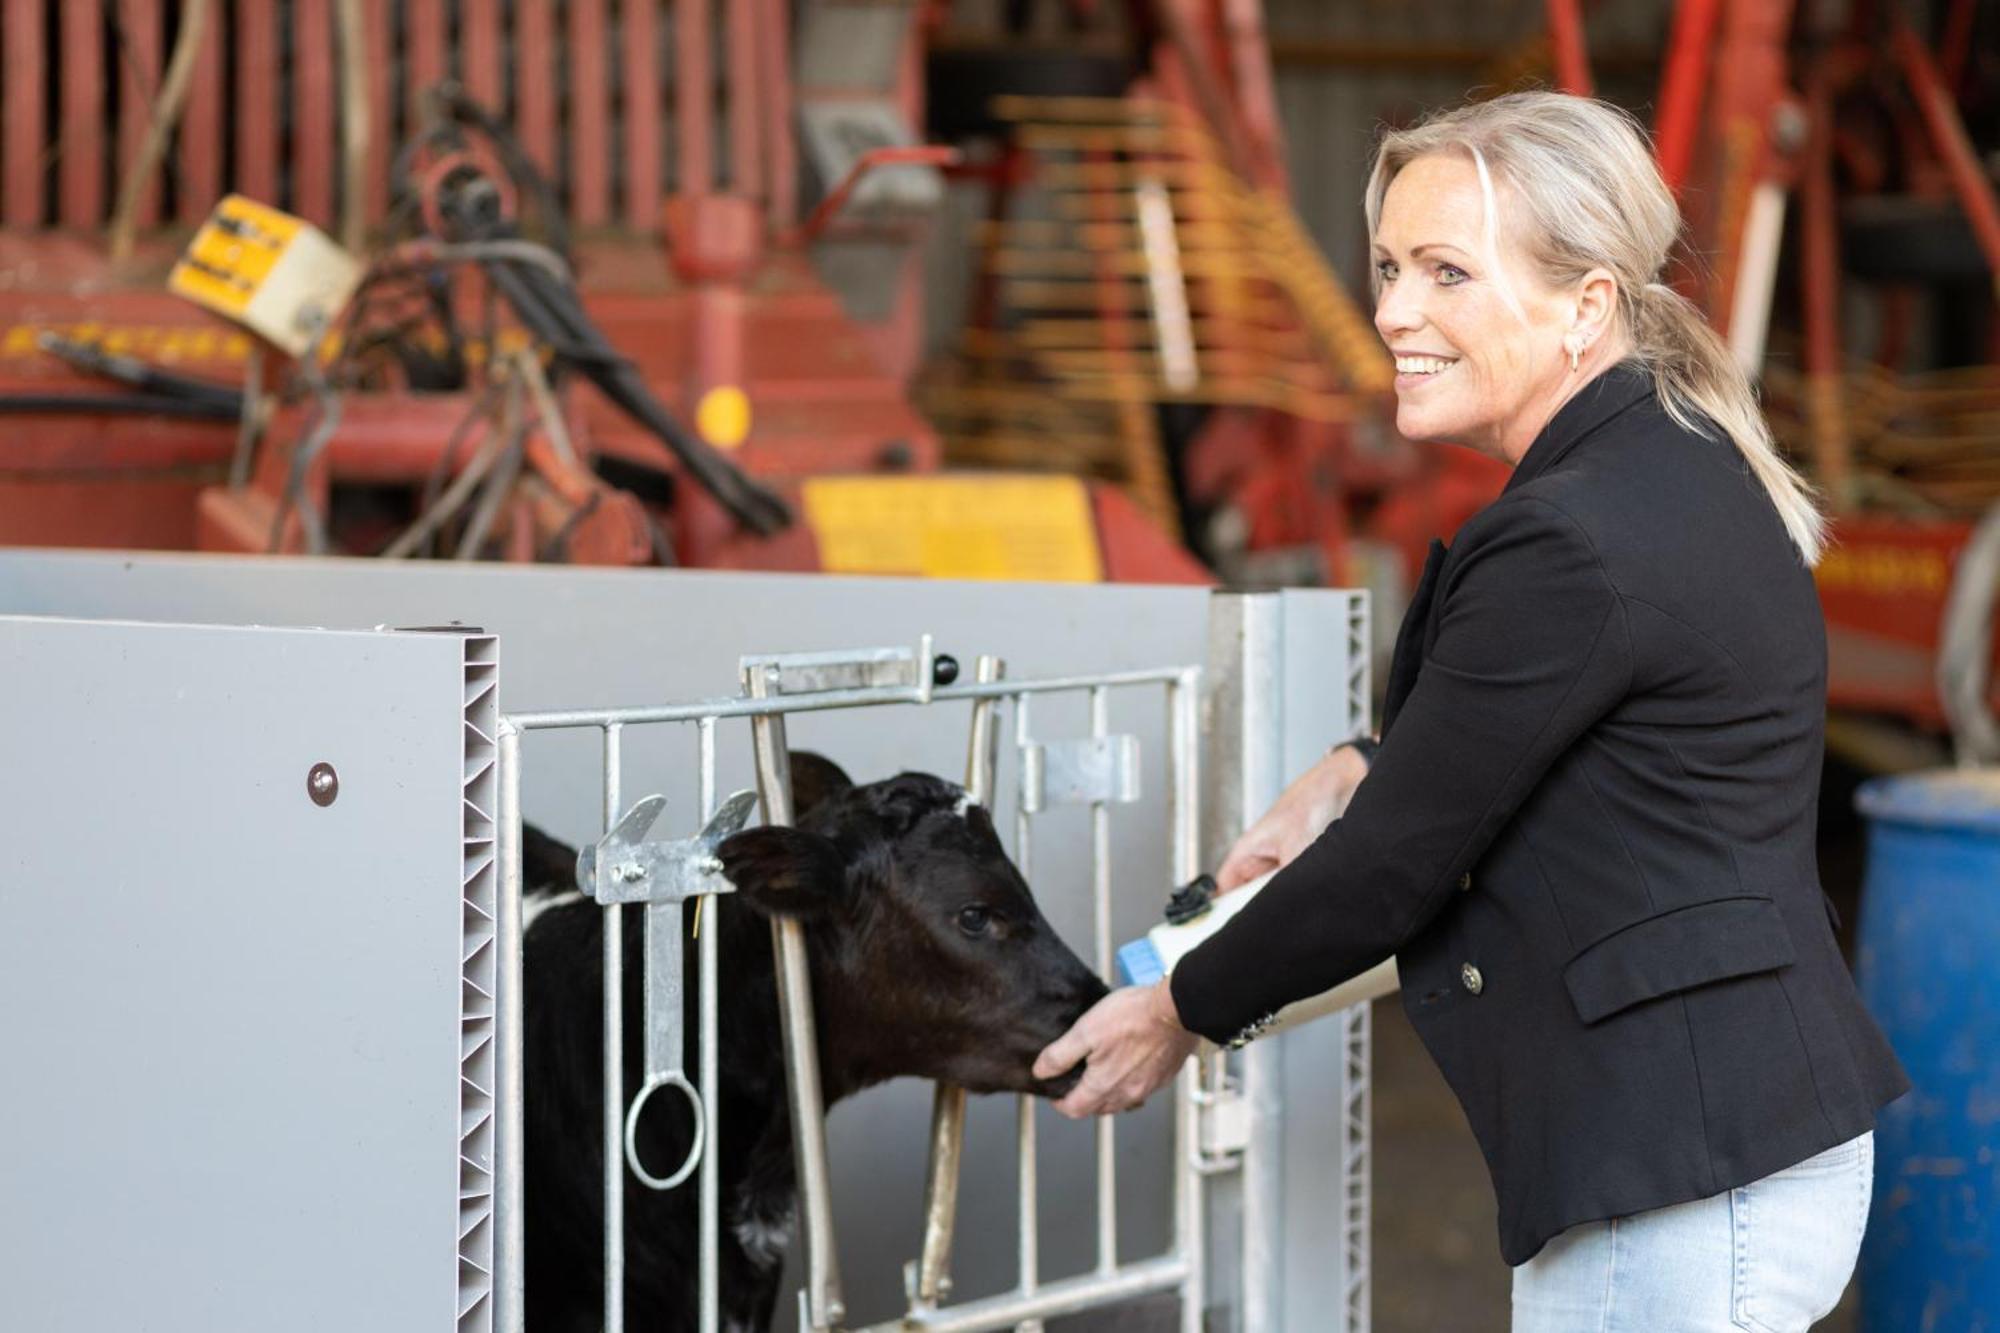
[744,667,846,1329]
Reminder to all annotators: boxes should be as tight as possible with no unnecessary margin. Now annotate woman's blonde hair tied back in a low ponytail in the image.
[1364,92,1826,566]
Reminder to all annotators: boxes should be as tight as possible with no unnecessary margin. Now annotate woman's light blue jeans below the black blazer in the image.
[1514,1133,1874,1333]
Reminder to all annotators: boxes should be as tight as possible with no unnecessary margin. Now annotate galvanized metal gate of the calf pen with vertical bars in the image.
[496,596,1368,1333]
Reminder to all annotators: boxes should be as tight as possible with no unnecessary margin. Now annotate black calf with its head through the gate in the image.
[522,753,1104,1333]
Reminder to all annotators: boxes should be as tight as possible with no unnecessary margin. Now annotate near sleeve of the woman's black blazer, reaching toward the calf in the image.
[1170,496,1632,1043]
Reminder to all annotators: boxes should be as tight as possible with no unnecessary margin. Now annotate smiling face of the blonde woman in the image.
[1374,152,1598,462]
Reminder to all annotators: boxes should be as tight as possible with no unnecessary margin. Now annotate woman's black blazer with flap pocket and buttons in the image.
[1172,362,1908,1263]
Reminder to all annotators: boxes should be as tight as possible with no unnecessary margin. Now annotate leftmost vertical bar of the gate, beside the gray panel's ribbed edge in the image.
[494,721,526,1333]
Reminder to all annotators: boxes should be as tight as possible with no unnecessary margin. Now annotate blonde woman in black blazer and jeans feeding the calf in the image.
[1036,94,1908,1333]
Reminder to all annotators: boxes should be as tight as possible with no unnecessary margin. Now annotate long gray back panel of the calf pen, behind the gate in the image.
[0,550,1346,1327]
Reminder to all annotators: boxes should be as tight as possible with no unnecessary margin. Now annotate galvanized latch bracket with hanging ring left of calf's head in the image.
[576,791,756,1189]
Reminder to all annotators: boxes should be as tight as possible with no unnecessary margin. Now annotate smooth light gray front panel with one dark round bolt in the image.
[0,618,470,1333]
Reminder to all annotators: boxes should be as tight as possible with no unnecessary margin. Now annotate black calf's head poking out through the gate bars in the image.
[720,753,1104,1097]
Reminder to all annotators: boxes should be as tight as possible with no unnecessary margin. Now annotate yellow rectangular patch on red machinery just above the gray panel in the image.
[804,474,1104,582]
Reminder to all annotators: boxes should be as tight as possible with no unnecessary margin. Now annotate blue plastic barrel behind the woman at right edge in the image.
[1856,769,2000,1333]
